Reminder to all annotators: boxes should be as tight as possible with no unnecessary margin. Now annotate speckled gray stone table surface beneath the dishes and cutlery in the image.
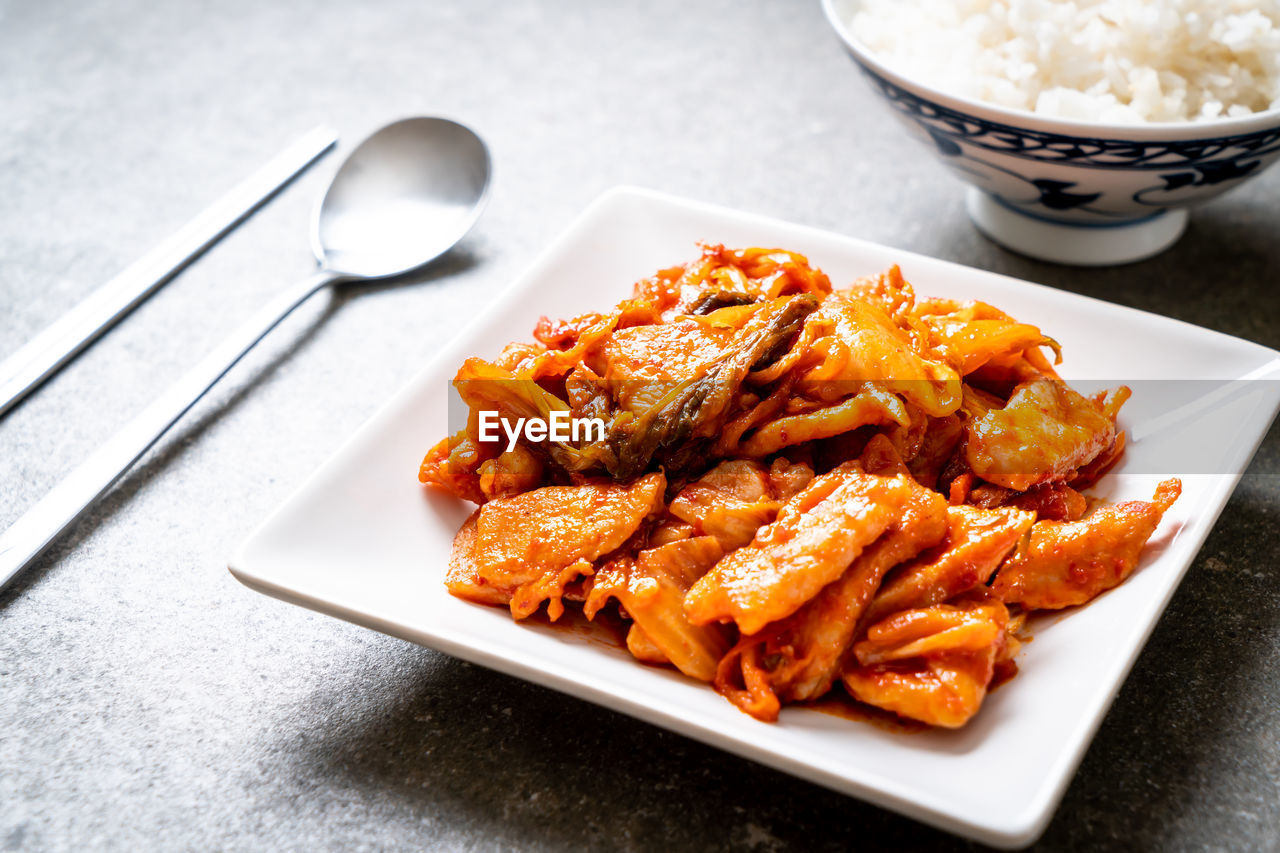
[0,0,1280,850]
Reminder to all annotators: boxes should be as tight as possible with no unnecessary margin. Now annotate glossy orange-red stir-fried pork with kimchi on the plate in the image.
[420,246,1181,727]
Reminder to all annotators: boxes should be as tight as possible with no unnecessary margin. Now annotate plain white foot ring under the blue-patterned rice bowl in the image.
[966,187,1187,266]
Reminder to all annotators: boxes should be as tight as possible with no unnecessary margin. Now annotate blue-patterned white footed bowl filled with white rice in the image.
[822,0,1280,265]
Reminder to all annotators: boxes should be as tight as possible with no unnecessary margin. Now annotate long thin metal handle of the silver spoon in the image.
[0,270,344,588]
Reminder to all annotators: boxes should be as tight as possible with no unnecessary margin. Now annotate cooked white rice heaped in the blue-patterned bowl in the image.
[850,0,1280,124]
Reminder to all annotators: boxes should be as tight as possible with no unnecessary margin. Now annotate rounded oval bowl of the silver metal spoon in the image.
[311,118,492,279]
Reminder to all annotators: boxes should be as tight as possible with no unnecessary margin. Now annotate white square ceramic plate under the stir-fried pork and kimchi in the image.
[230,188,1280,847]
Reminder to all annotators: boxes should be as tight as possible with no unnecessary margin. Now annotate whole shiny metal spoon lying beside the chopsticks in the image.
[0,118,490,588]
